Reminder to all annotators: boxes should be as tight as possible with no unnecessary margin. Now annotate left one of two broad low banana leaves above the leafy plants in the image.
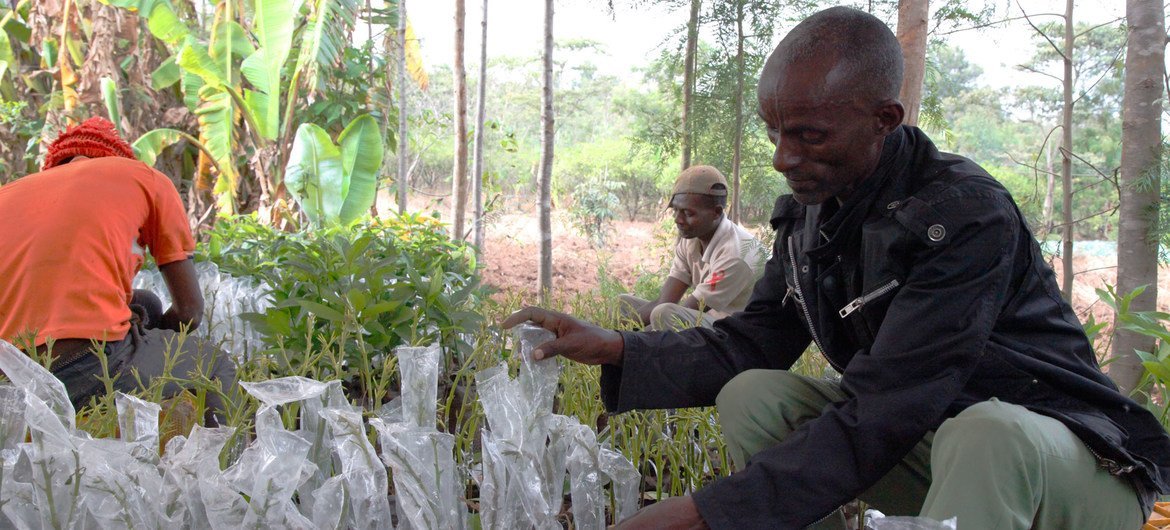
[284,123,345,226]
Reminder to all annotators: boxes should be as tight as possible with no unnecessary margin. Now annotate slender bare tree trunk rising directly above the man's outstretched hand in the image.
[537,0,555,305]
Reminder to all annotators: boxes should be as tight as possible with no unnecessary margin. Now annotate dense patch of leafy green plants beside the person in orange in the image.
[199,214,486,407]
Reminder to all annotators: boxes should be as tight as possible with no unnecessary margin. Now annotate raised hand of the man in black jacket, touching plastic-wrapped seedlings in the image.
[502,307,624,365]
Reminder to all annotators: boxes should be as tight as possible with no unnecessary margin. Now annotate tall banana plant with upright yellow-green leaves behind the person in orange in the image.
[115,0,359,214]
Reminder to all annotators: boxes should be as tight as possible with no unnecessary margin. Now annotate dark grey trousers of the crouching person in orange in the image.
[53,323,236,425]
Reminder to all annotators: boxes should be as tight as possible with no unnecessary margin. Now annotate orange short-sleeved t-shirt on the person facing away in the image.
[0,157,195,345]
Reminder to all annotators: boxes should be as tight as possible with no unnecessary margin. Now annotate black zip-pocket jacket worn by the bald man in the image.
[601,126,1170,528]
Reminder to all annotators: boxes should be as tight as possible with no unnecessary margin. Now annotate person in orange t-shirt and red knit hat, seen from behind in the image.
[0,118,235,424]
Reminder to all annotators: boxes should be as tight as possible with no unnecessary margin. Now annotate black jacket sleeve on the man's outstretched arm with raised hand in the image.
[601,229,811,412]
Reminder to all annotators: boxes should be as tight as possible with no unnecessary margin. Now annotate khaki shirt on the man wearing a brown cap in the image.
[670,216,768,318]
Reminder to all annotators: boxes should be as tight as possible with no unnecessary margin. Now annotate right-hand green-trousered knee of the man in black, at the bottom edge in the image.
[922,399,1144,530]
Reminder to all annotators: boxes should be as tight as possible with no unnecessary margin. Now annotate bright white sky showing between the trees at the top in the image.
[406,0,1124,87]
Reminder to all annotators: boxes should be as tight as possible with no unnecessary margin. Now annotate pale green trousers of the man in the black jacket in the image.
[716,370,1147,530]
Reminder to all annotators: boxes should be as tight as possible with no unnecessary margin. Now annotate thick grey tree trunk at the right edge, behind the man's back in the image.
[1109,0,1165,394]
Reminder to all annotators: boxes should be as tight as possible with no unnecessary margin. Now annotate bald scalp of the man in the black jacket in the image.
[761,7,903,103]
